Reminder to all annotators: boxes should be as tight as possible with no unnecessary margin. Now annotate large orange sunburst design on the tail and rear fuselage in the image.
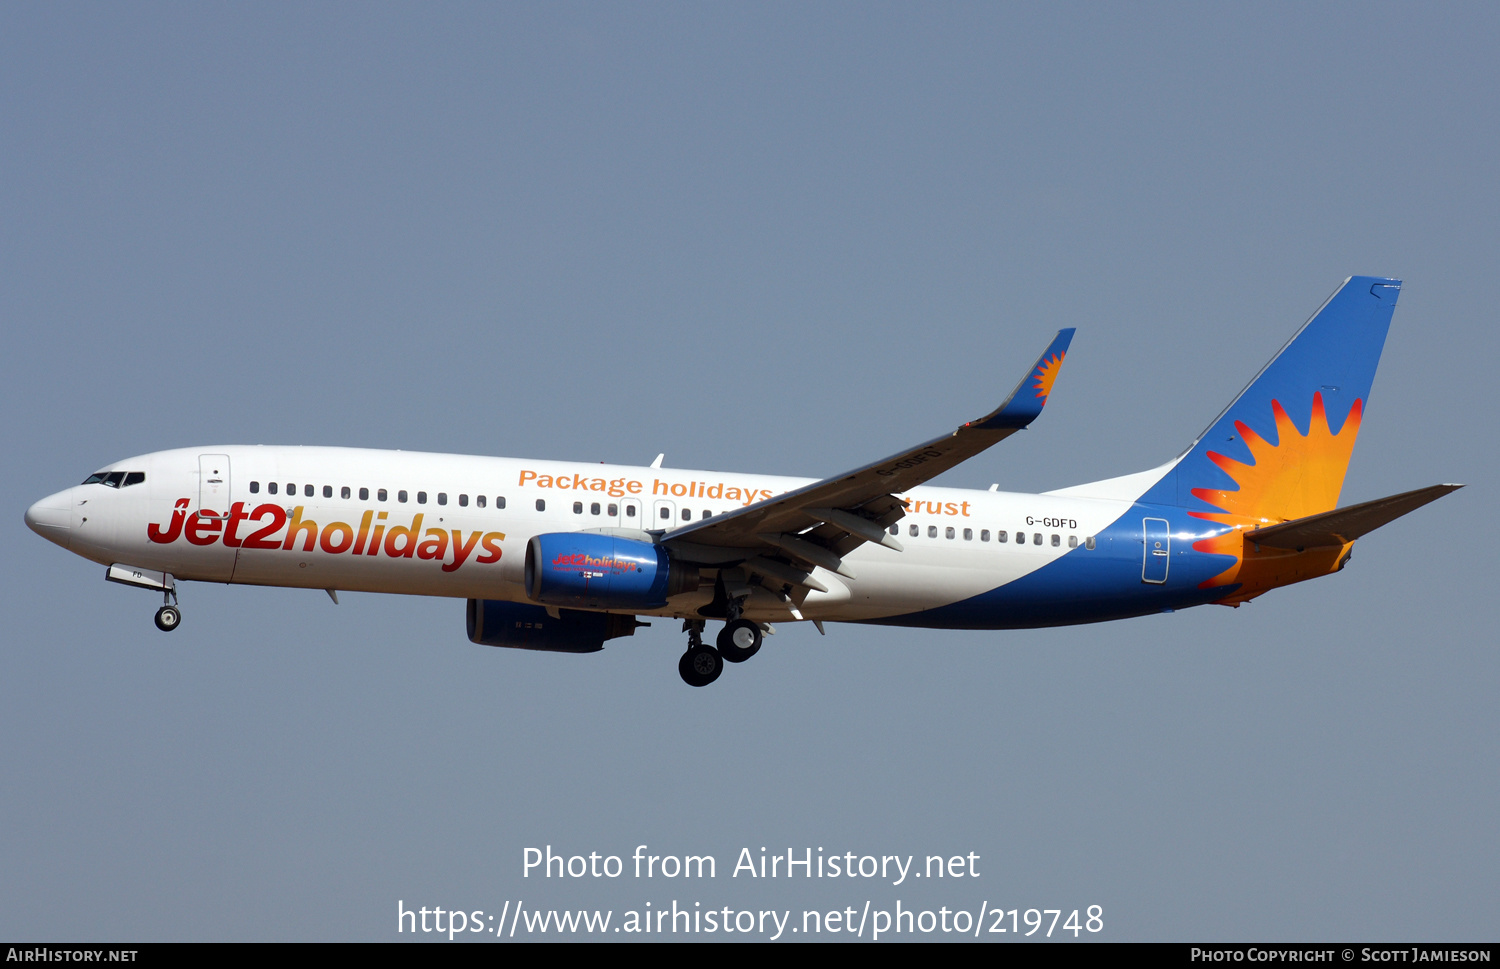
[1190,393,1364,602]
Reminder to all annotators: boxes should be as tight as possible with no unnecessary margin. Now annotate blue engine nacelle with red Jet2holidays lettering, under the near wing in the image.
[527,531,698,609]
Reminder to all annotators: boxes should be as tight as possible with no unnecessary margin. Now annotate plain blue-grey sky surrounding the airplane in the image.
[0,5,1500,941]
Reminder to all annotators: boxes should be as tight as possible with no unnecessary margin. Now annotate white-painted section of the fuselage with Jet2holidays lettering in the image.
[29,446,1139,621]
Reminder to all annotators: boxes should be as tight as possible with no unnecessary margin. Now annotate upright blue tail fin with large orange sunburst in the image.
[1142,276,1401,527]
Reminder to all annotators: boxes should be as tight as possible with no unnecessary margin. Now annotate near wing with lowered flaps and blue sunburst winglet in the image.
[660,327,1073,588]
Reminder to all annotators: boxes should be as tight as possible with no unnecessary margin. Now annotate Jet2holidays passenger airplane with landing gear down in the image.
[26,276,1463,687]
